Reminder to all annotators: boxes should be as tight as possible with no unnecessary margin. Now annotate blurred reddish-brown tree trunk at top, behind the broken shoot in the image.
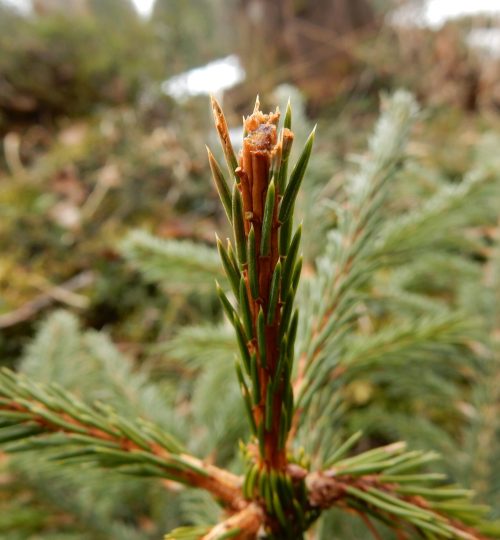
[237,0,379,109]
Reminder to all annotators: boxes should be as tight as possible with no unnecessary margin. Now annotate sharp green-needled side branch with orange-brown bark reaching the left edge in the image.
[0,369,244,511]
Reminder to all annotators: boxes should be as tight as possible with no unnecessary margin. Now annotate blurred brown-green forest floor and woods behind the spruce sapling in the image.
[0,0,500,361]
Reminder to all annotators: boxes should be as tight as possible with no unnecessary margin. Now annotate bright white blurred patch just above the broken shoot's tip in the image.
[161,54,245,99]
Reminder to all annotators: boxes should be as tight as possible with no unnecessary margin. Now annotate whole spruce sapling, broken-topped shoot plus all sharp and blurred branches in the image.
[0,91,500,540]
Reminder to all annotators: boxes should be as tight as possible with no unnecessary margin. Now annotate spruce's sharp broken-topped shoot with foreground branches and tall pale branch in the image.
[0,92,500,540]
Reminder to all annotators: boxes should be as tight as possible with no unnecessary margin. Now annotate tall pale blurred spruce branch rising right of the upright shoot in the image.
[290,92,417,432]
